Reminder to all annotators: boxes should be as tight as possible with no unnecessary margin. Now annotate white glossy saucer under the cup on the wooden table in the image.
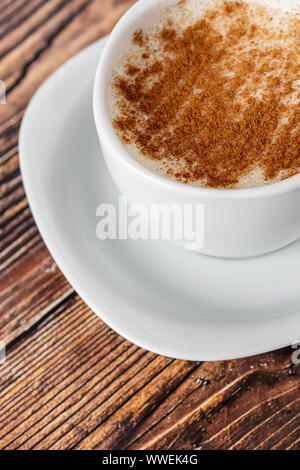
[20,41,300,360]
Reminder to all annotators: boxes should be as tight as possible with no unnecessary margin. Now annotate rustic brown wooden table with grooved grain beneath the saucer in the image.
[0,0,300,450]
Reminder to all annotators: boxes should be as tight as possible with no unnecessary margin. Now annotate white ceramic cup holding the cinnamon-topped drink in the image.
[93,0,300,257]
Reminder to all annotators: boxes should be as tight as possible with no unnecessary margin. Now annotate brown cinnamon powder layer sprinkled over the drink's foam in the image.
[113,1,300,188]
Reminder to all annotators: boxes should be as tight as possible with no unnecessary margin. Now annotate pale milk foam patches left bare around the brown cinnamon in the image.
[110,0,300,189]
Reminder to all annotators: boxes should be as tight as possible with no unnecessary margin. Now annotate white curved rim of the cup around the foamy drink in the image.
[93,0,300,199]
